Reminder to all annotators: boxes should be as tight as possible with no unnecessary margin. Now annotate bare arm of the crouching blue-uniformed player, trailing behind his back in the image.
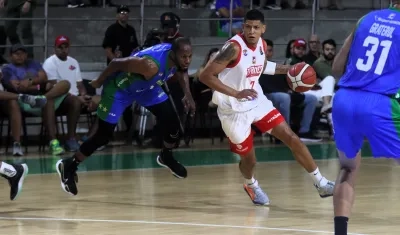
[91,57,158,88]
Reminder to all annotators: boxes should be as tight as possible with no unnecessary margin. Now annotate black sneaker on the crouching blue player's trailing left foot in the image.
[56,158,78,195]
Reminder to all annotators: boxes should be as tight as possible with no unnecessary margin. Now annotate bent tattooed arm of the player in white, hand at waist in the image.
[199,42,240,97]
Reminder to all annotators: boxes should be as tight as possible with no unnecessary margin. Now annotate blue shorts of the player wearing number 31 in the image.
[332,88,400,158]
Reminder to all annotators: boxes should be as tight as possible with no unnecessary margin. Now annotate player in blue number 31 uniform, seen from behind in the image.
[332,0,400,235]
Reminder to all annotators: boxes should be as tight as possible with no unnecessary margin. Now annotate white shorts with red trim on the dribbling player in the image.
[218,95,285,154]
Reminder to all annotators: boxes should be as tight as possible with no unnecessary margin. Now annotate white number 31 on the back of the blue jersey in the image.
[356,36,392,75]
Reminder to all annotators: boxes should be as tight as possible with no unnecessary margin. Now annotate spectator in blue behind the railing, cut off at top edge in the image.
[215,0,245,34]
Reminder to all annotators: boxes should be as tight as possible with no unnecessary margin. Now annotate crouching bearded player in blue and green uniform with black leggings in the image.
[56,38,195,195]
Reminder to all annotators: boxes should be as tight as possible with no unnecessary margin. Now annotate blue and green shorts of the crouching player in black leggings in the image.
[97,80,168,124]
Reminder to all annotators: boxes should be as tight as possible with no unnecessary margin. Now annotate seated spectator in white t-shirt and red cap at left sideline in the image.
[43,36,100,151]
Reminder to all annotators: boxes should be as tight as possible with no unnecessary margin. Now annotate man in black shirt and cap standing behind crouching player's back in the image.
[103,5,139,138]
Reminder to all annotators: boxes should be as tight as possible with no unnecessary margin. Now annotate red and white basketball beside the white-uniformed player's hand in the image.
[286,62,317,92]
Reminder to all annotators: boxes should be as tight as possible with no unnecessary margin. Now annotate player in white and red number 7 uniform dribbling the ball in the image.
[200,10,335,205]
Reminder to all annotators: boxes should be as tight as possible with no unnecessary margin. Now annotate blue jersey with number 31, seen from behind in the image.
[338,8,400,95]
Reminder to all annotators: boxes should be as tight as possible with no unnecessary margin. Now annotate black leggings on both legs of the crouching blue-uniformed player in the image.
[79,100,180,157]
